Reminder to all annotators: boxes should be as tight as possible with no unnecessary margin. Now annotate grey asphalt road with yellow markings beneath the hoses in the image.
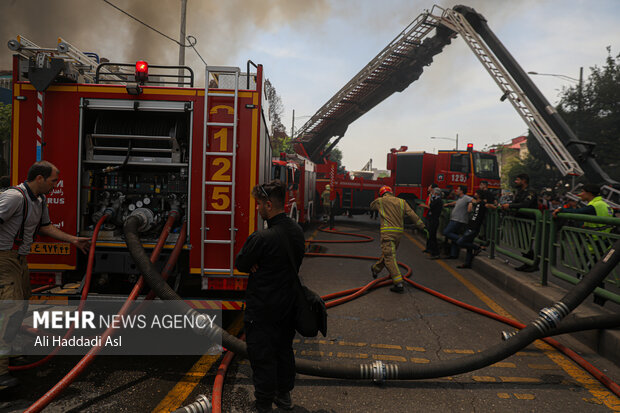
[0,216,620,413]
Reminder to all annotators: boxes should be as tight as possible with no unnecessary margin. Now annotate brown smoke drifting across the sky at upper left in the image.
[0,0,329,83]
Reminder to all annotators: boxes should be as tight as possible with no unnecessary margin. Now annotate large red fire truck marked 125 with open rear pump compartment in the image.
[9,37,271,302]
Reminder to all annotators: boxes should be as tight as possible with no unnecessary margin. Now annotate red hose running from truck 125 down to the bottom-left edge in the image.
[26,211,187,413]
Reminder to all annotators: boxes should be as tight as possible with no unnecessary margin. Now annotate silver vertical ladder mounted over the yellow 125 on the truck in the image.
[200,66,240,282]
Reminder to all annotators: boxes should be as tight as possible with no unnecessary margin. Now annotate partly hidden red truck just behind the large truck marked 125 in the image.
[271,153,316,226]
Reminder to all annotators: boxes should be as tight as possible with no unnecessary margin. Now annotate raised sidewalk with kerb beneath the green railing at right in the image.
[473,251,620,365]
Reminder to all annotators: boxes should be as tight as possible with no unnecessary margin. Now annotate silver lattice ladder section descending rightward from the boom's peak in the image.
[438,7,583,176]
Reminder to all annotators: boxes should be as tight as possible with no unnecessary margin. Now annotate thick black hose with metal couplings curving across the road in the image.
[118,220,620,412]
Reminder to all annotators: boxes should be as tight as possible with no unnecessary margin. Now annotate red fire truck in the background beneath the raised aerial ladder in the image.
[317,144,500,213]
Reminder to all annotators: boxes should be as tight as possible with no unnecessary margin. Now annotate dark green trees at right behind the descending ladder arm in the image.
[506,47,620,190]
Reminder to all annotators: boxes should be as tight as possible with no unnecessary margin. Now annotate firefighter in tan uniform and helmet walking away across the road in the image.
[370,185,428,293]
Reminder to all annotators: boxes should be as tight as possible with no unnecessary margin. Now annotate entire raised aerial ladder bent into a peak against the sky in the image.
[294,6,620,207]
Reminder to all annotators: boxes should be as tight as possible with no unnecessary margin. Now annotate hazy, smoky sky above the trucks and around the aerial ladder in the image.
[0,0,620,170]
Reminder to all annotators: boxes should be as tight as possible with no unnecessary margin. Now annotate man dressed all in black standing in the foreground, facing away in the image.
[235,180,305,412]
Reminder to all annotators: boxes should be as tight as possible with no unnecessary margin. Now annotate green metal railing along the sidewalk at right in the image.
[414,204,620,304]
